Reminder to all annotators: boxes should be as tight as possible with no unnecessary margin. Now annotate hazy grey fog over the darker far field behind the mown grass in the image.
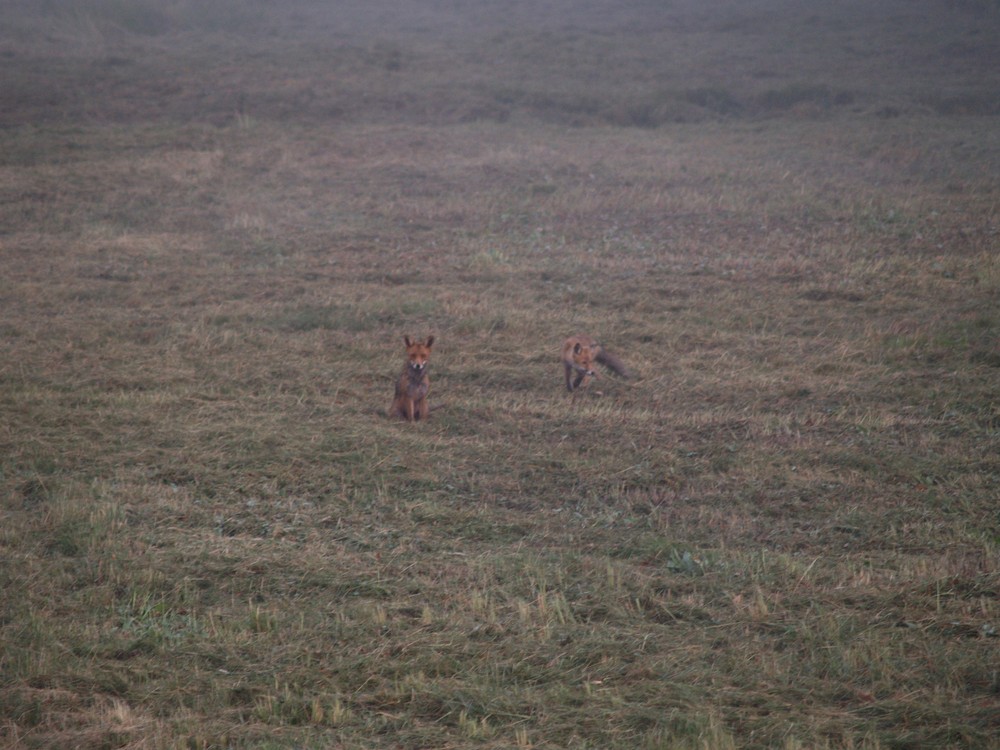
[0,0,1000,127]
